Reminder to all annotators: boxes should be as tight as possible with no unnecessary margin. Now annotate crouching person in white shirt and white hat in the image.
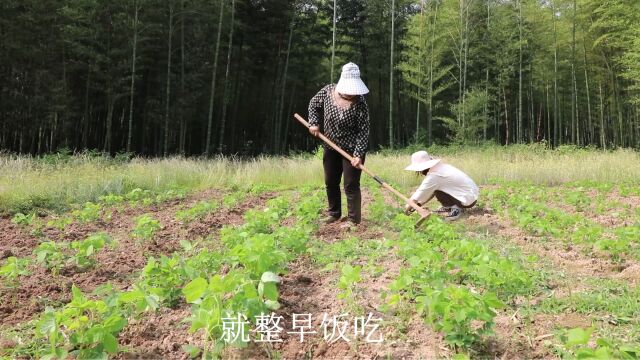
[405,151,479,221]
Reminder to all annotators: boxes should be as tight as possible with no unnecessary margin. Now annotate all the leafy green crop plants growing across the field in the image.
[0,181,640,359]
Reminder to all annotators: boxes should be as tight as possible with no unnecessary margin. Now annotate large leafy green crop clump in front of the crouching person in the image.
[383,214,535,349]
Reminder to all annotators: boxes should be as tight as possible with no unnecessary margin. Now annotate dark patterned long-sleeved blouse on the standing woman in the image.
[309,84,369,157]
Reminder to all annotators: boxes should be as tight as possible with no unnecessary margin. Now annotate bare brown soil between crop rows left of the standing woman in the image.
[0,190,274,325]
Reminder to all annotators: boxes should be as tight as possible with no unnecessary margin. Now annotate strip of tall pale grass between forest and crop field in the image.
[0,145,640,213]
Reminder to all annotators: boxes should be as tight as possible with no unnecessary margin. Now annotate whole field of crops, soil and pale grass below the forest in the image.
[0,146,640,359]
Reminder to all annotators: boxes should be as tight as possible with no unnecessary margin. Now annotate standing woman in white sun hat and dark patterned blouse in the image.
[309,63,369,228]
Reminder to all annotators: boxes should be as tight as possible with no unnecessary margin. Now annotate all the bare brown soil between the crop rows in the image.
[0,184,640,359]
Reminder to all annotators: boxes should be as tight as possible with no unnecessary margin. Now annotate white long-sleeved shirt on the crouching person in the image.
[411,162,480,206]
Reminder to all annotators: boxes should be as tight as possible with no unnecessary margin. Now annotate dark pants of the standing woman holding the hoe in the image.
[322,149,364,224]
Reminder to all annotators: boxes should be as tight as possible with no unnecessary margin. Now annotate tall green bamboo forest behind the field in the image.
[0,0,640,156]
